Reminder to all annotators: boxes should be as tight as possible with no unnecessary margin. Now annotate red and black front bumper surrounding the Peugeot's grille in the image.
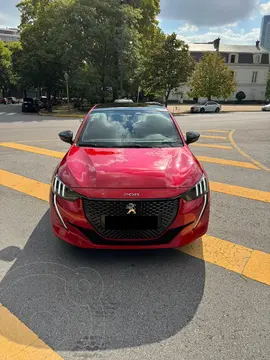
[50,193,210,249]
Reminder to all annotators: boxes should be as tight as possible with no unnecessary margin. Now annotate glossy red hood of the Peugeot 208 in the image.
[57,145,202,189]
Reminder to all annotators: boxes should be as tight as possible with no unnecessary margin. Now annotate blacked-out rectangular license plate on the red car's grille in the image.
[101,215,159,230]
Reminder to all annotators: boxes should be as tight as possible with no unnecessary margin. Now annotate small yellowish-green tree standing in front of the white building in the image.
[189,52,236,100]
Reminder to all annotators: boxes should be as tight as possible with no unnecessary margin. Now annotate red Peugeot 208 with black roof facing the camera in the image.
[50,104,210,249]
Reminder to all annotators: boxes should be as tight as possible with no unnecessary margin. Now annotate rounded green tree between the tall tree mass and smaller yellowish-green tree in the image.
[142,33,194,105]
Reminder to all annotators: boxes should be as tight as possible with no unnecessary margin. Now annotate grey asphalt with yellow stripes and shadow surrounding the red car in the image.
[0,113,270,360]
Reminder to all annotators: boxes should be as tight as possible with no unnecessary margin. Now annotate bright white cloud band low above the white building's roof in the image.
[177,26,260,45]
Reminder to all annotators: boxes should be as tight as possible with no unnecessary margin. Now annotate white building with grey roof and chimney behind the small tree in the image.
[169,39,270,101]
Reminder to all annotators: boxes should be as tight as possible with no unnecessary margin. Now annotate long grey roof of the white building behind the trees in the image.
[188,43,269,54]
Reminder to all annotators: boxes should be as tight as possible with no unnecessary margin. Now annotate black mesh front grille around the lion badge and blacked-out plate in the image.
[83,199,179,239]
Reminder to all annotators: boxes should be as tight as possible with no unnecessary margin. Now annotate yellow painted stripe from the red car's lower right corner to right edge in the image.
[178,235,270,285]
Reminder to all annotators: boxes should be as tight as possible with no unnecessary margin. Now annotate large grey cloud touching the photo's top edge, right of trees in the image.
[161,0,258,26]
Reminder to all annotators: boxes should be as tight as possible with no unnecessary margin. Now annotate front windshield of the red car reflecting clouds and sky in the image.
[78,108,183,148]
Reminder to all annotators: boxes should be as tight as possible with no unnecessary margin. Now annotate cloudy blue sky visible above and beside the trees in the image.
[0,0,270,45]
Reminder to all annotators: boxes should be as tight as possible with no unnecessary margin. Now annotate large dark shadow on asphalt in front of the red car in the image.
[0,211,205,352]
